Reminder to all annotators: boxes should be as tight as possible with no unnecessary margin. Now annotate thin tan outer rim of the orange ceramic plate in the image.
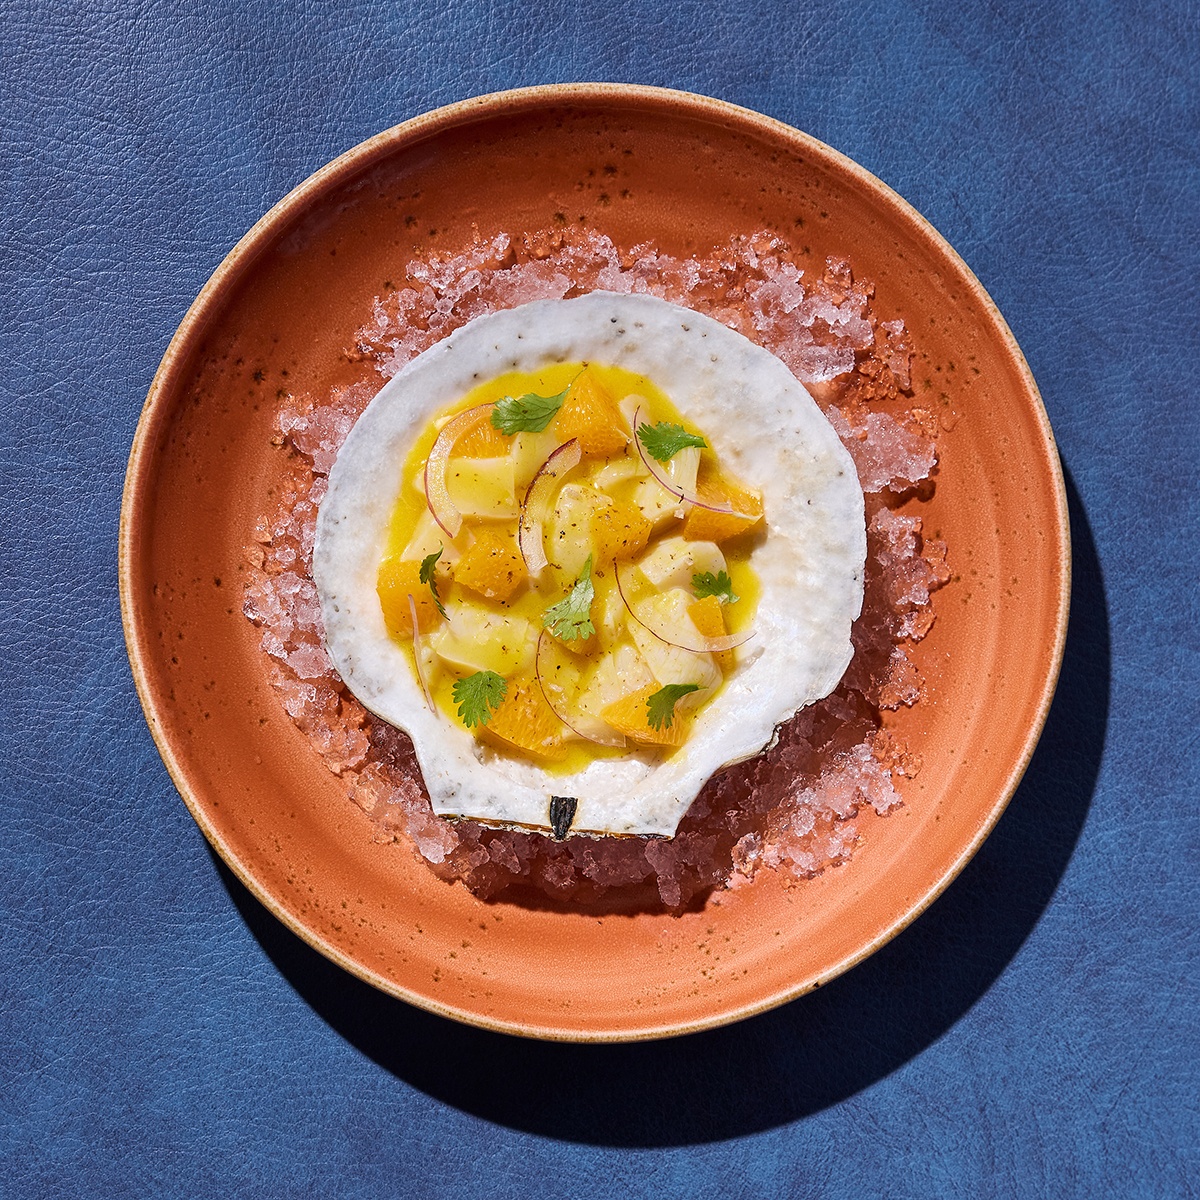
[118,83,1072,1043]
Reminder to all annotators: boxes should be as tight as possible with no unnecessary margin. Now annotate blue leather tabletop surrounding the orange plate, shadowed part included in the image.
[0,0,1200,1198]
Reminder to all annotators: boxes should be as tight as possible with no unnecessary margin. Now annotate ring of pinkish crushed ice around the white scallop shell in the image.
[242,232,949,908]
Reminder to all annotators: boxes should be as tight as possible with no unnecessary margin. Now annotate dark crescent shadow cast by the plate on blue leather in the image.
[214,475,1110,1146]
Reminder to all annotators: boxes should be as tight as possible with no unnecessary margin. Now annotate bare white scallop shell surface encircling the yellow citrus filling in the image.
[313,292,866,836]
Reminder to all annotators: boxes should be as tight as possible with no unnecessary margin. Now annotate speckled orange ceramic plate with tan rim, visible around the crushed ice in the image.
[120,85,1069,1040]
